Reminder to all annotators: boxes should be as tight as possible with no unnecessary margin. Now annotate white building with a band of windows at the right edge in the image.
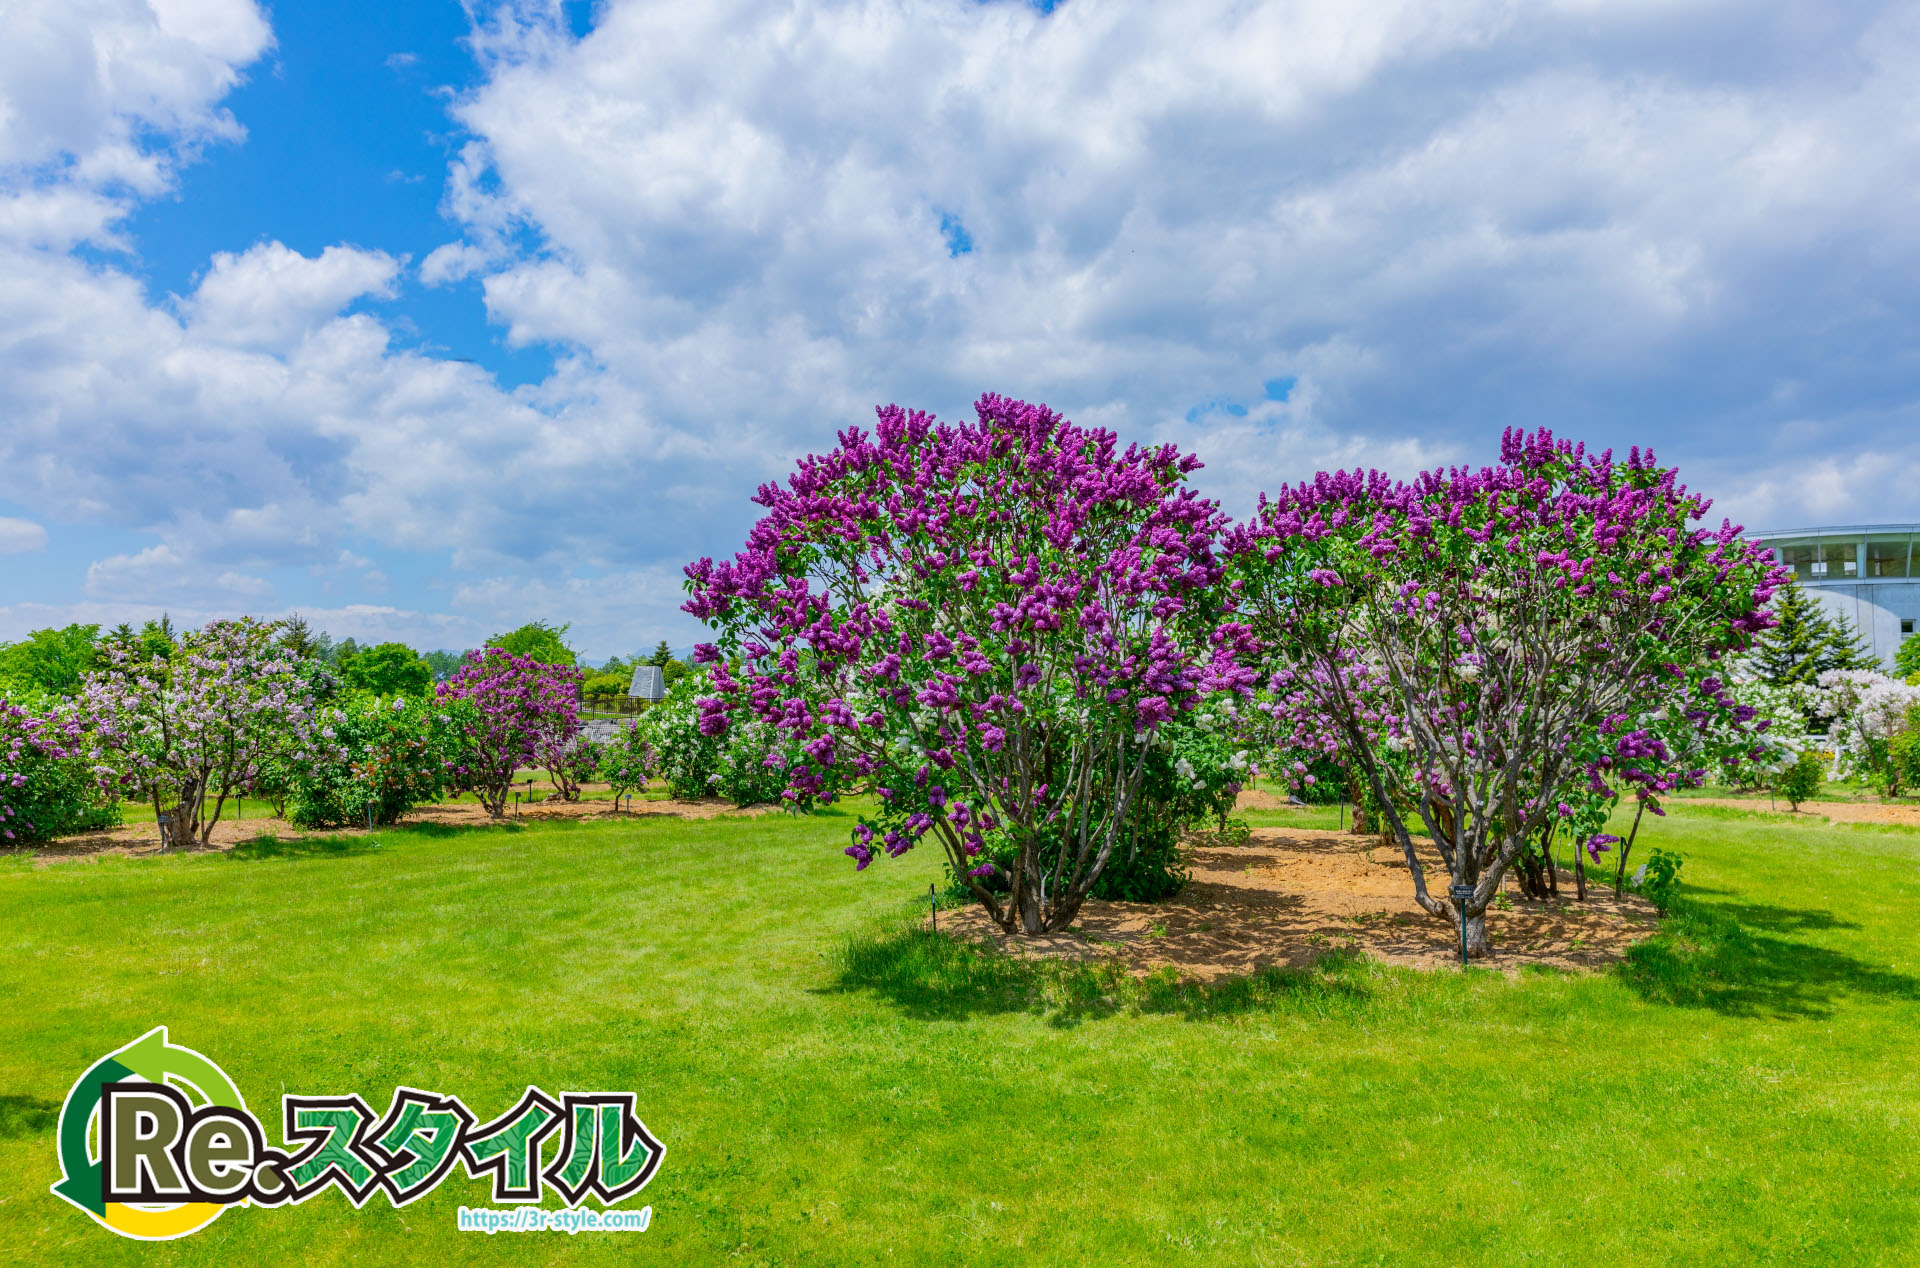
[1751,524,1920,669]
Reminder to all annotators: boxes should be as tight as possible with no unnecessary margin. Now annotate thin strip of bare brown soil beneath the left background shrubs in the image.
[13,797,776,865]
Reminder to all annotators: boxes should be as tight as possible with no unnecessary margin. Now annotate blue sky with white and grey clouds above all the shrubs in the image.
[0,0,1920,657]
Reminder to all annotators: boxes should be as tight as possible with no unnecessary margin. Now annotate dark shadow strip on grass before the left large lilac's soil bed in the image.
[826,922,1397,1026]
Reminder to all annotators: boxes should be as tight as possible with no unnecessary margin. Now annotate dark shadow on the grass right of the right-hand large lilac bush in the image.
[1619,893,1920,1018]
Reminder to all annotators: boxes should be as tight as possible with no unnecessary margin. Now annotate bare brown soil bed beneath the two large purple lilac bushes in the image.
[941,826,1659,982]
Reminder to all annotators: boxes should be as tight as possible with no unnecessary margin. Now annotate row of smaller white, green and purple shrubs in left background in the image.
[0,619,606,843]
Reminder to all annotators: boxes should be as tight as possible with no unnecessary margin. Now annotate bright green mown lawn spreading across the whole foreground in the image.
[0,805,1920,1268]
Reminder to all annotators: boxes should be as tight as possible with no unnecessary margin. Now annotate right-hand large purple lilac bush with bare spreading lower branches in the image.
[1229,430,1784,953]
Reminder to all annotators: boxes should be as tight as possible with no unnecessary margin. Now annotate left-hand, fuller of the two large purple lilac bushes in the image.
[685,396,1252,934]
